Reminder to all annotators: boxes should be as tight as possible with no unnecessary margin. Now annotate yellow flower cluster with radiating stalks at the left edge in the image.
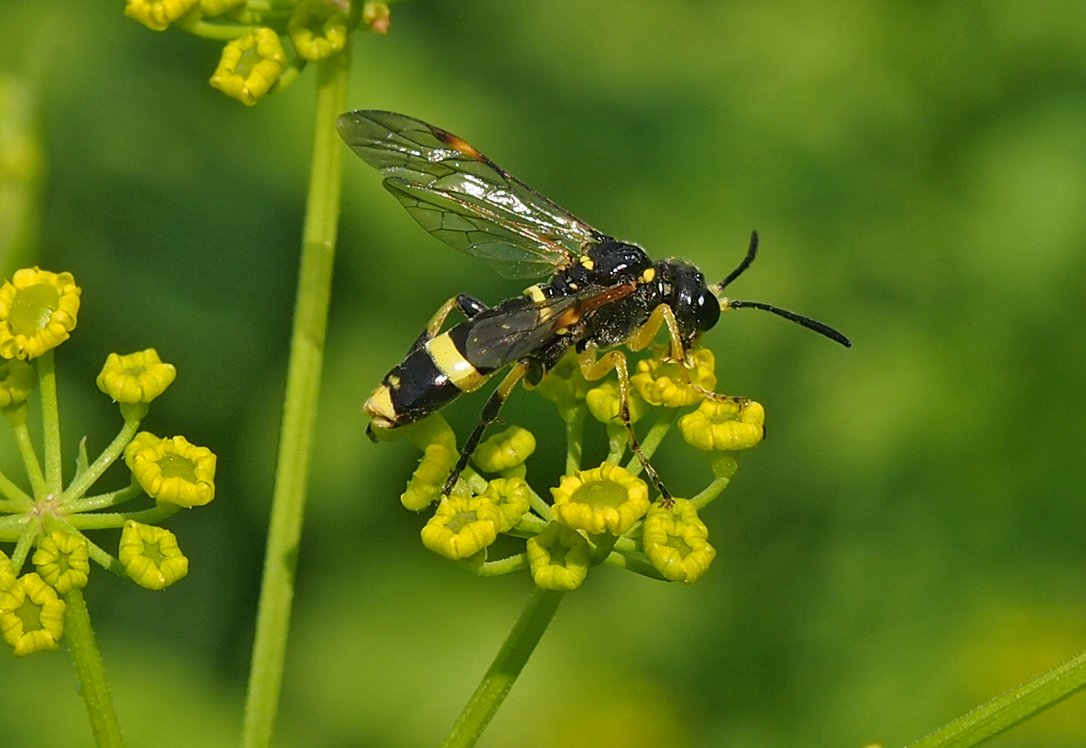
[0,267,215,656]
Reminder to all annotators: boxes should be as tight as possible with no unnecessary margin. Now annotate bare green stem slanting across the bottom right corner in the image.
[909,651,1086,748]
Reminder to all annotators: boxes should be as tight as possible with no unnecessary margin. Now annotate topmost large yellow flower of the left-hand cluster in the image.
[0,267,79,358]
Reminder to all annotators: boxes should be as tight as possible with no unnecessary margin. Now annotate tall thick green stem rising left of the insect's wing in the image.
[242,51,350,748]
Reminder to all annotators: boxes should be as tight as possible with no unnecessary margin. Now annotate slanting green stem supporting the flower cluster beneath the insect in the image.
[443,588,565,748]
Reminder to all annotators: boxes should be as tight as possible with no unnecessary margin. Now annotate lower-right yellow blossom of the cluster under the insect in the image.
[641,498,717,584]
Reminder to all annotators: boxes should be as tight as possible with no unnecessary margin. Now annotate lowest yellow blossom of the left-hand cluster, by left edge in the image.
[0,572,65,657]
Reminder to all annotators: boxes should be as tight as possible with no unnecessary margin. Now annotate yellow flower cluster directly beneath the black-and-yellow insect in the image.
[393,348,765,589]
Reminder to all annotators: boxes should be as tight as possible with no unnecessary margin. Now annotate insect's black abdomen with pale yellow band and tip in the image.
[364,320,493,429]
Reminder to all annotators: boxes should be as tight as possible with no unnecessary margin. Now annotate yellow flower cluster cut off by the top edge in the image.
[125,0,391,106]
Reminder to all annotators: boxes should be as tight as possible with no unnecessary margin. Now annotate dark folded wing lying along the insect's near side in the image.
[465,283,636,369]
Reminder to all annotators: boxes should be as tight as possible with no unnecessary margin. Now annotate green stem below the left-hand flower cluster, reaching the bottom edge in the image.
[64,589,124,748]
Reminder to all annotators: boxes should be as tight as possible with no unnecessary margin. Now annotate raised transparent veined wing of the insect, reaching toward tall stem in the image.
[338,111,605,278]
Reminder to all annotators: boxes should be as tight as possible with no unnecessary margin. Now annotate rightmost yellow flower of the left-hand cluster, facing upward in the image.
[125,431,216,507]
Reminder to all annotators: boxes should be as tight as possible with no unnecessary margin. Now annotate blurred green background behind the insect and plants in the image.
[0,0,1086,748]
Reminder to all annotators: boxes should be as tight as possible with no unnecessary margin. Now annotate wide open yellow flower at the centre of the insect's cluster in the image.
[551,462,649,535]
